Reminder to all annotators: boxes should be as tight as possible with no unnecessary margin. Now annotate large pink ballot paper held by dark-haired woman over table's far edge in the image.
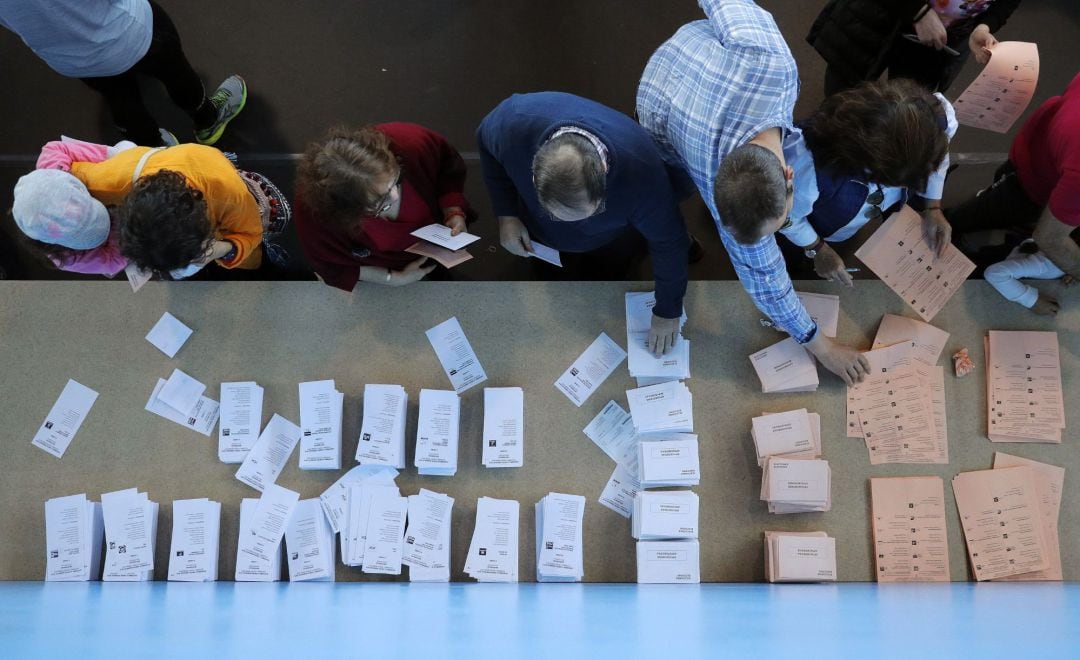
[855,206,975,322]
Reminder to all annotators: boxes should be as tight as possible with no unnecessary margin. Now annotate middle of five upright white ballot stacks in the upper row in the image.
[356,385,408,470]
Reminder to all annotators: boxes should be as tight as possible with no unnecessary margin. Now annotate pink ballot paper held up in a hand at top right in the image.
[954,41,1039,133]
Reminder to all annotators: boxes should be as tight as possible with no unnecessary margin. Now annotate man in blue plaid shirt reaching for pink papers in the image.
[637,0,869,385]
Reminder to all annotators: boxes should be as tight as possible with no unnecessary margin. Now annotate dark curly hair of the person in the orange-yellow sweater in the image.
[118,170,214,272]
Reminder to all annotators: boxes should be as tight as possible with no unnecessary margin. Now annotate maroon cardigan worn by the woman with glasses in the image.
[293,123,475,291]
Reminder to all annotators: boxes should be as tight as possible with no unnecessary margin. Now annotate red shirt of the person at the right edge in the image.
[1009,76,1080,227]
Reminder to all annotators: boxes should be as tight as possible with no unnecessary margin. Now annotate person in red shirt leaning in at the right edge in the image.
[945,75,1080,279]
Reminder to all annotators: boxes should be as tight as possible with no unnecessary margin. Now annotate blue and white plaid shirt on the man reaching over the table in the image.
[637,0,818,344]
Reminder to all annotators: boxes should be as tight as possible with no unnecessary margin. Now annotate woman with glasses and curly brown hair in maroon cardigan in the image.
[293,123,475,291]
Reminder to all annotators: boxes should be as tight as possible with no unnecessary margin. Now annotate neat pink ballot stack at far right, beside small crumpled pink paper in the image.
[984,331,1065,443]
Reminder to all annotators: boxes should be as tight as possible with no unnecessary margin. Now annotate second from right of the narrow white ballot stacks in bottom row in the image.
[465,497,521,582]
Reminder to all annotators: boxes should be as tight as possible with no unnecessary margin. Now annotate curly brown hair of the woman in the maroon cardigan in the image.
[296,125,401,225]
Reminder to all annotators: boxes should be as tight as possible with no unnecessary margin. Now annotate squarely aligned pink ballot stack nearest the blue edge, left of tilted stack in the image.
[870,476,949,582]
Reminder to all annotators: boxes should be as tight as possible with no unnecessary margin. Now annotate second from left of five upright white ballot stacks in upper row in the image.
[299,380,345,470]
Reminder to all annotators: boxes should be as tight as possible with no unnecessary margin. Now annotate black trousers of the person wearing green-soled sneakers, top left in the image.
[82,1,217,146]
